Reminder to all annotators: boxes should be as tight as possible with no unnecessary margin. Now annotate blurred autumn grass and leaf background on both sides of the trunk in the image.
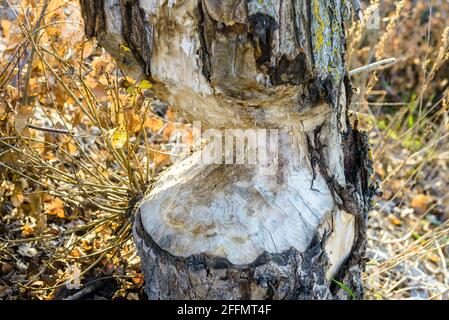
[0,0,449,300]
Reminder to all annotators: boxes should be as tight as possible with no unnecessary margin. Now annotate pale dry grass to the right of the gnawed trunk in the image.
[348,1,449,299]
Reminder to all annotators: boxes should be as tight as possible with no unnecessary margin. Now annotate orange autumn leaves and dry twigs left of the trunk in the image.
[0,0,188,299]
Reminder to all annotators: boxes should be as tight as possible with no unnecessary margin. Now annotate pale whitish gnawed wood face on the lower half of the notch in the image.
[140,132,352,265]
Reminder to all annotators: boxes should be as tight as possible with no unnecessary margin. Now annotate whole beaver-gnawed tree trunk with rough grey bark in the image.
[80,0,372,299]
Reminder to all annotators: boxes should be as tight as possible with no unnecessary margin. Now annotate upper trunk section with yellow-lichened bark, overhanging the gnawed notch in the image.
[81,0,348,128]
